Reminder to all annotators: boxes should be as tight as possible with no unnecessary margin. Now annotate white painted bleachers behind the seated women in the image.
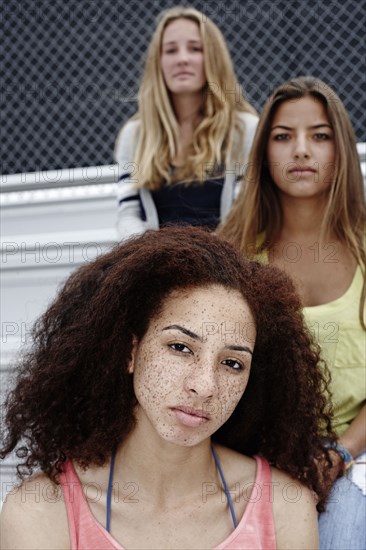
[0,143,366,502]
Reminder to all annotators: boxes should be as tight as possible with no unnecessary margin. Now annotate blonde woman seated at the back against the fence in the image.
[115,7,258,239]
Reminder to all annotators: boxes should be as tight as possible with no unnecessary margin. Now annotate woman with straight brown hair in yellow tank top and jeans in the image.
[219,77,366,550]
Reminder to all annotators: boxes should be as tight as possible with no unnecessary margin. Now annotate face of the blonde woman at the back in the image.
[160,18,206,94]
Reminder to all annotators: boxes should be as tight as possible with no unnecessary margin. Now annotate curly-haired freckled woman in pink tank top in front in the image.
[1,227,333,550]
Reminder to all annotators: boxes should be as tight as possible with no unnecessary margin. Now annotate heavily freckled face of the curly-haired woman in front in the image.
[130,285,255,446]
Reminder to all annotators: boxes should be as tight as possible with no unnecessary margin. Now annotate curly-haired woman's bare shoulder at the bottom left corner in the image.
[1,474,70,550]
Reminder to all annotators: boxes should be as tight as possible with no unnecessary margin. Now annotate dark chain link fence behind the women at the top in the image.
[0,0,366,174]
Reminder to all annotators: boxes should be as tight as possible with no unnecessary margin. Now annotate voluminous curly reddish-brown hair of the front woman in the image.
[1,227,334,508]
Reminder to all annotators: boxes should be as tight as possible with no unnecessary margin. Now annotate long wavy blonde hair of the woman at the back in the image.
[116,6,256,189]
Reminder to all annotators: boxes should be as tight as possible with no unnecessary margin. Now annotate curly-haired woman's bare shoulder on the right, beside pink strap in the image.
[271,468,319,550]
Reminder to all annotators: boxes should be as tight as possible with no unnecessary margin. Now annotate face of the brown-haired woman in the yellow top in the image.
[267,97,335,203]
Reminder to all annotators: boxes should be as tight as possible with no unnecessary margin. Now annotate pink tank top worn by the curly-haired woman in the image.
[60,456,276,550]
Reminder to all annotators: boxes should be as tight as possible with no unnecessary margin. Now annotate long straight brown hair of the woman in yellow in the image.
[218,77,366,329]
